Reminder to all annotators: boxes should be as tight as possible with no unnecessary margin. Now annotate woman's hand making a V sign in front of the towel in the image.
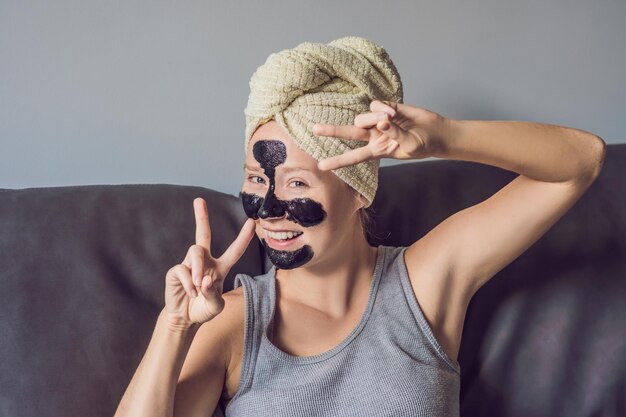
[313,100,450,171]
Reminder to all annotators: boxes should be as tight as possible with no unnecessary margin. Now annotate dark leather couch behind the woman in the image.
[0,144,626,417]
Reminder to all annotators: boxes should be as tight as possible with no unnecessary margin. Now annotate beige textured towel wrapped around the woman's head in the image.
[244,36,403,207]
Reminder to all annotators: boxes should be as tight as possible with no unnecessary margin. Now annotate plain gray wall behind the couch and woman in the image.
[0,0,626,194]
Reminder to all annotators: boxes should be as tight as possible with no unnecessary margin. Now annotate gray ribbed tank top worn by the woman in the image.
[214,246,461,417]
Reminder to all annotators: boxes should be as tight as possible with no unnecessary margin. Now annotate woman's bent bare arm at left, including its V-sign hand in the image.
[115,198,255,417]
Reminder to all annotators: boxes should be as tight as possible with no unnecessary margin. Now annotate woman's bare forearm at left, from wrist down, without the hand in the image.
[114,308,200,417]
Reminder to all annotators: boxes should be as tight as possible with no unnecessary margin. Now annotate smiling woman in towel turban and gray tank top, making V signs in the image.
[116,37,605,417]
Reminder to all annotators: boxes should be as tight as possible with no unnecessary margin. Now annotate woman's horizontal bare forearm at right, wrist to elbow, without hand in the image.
[432,119,605,183]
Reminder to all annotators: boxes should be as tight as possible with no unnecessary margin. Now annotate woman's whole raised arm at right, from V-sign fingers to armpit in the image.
[313,100,606,358]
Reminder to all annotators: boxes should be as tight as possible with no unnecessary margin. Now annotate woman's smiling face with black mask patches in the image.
[240,120,361,269]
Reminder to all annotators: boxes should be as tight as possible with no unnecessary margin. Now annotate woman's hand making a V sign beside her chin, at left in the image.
[165,198,256,329]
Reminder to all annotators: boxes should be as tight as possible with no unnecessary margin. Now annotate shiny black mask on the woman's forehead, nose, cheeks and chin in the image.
[239,140,326,269]
